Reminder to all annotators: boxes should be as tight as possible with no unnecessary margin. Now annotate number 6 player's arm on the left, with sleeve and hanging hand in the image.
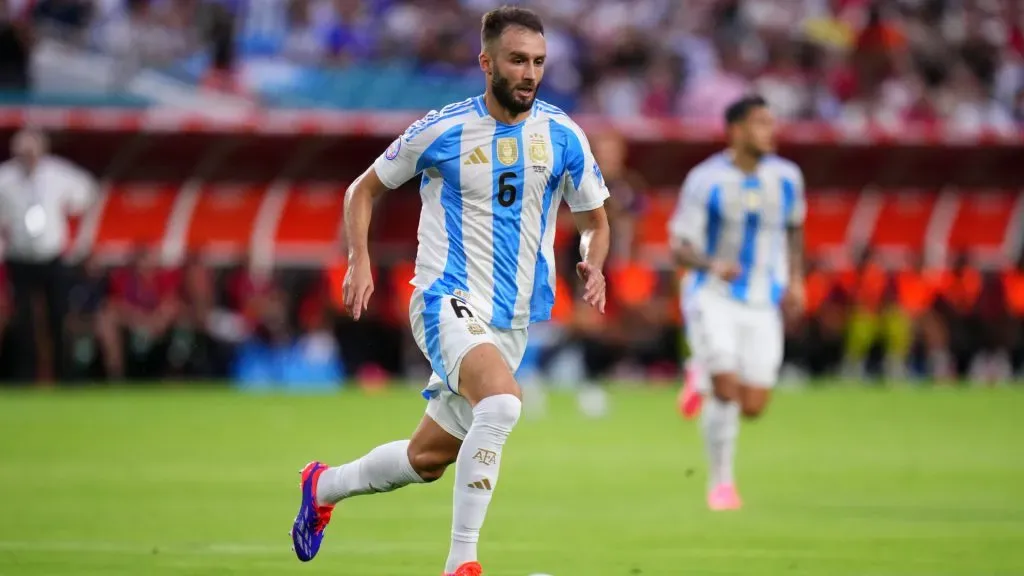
[343,111,445,320]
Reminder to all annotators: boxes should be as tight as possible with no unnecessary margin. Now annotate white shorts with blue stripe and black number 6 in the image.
[409,288,526,440]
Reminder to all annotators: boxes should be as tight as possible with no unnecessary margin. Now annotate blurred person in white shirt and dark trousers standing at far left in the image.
[0,129,96,381]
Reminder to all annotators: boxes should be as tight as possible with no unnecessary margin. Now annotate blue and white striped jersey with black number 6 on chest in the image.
[374,95,608,329]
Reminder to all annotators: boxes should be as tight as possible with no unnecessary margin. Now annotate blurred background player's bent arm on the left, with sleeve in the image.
[669,168,740,281]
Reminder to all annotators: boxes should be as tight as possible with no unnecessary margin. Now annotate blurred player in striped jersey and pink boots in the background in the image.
[669,96,807,510]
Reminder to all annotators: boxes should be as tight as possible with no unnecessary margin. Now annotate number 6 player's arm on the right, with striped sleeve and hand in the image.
[562,124,611,314]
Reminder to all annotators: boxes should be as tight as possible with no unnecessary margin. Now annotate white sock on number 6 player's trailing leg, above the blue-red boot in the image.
[316,440,423,504]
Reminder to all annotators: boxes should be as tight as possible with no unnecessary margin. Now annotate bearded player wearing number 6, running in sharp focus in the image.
[292,7,609,576]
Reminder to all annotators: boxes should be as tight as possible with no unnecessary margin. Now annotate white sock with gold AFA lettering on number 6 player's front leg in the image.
[444,394,522,573]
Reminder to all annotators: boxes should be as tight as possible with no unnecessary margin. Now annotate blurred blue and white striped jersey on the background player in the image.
[669,152,807,306]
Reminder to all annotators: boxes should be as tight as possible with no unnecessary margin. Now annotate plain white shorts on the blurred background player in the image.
[683,289,783,388]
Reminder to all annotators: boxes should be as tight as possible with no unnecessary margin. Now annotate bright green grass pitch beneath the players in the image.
[0,381,1024,576]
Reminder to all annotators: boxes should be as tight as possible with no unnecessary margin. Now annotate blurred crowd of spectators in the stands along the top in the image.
[5,0,1024,124]
